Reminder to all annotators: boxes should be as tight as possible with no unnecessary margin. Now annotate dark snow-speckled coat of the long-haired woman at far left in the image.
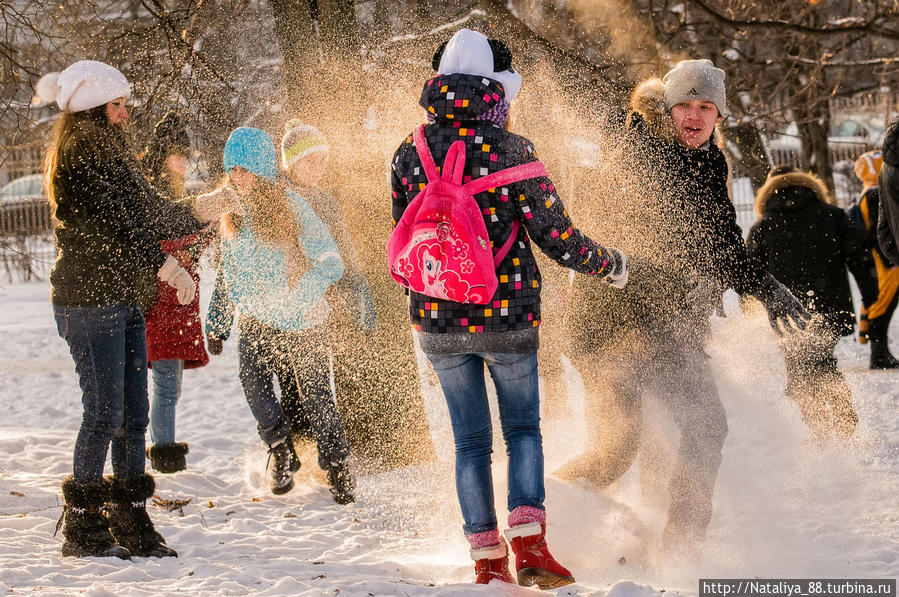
[50,114,202,311]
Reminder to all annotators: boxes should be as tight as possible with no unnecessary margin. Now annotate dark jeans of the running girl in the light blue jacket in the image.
[237,317,350,468]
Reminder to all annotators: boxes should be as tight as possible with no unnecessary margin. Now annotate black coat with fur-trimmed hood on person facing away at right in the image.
[747,172,878,336]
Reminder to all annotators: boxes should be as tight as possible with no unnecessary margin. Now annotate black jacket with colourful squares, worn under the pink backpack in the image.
[391,74,617,354]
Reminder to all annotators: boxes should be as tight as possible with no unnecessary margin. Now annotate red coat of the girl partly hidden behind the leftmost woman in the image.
[146,228,212,369]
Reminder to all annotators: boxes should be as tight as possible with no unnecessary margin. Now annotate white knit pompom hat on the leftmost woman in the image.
[34,60,131,112]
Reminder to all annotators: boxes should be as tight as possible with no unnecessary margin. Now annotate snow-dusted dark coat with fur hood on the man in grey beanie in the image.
[566,79,765,353]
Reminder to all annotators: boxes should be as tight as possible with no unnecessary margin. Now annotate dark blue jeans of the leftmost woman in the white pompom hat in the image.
[53,303,149,483]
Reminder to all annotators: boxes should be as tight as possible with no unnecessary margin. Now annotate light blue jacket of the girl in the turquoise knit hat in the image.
[206,190,343,338]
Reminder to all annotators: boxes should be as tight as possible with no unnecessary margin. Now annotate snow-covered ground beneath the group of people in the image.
[0,283,899,597]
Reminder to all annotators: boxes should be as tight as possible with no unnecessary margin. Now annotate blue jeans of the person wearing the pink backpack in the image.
[428,352,545,534]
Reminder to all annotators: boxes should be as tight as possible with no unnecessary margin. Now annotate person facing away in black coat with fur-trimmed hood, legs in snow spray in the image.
[747,166,878,437]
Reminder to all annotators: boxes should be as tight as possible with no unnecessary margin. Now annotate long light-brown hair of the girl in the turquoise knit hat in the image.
[220,176,309,288]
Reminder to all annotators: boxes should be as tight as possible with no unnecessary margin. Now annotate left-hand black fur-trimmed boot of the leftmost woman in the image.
[56,475,131,560]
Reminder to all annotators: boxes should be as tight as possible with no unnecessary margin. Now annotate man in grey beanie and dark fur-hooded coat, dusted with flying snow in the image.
[556,53,808,566]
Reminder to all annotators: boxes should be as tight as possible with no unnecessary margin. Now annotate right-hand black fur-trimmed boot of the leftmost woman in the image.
[107,474,178,558]
